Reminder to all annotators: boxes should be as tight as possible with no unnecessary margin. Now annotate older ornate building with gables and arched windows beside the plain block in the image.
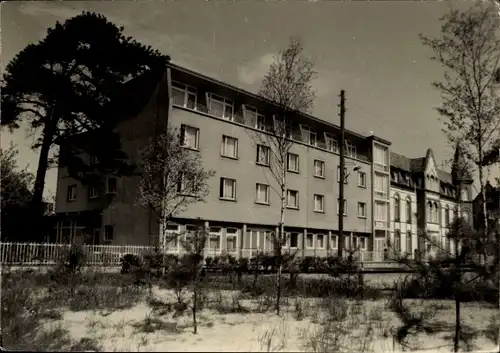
[391,149,472,254]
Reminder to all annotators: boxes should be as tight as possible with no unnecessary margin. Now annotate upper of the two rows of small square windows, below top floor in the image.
[181,125,366,187]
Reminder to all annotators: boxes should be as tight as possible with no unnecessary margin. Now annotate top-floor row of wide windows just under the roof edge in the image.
[172,82,358,158]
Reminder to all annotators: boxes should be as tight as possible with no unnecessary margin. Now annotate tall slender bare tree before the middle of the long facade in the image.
[245,37,316,314]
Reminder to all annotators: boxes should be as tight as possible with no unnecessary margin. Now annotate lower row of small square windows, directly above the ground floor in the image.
[219,178,367,218]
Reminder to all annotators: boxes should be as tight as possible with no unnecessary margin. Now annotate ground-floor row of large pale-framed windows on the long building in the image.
[166,225,367,251]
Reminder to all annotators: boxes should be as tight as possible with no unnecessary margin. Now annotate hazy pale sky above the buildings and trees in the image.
[1,0,500,196]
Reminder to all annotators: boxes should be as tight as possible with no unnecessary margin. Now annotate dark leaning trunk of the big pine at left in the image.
[31,125,54,217]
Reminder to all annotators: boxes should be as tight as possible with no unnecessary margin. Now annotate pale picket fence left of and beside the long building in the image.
[0,243,153,266]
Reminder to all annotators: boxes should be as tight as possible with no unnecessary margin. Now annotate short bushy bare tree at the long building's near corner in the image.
[138,127,215,262]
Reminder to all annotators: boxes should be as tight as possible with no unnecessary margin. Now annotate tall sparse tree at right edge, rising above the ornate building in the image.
[421,2,500,243]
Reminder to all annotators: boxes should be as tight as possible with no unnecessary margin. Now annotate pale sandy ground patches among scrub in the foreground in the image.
[40,288,497,353]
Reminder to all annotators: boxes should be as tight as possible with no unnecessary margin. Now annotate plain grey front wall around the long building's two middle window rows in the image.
[171,107,371,233]
